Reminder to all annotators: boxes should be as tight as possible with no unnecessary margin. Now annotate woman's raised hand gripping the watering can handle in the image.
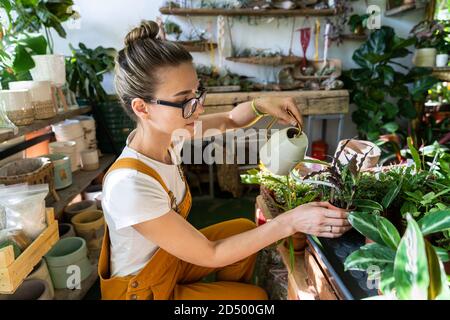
[255,97,303,127]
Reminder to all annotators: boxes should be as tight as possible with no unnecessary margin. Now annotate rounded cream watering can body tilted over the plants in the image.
[259,127,308,175]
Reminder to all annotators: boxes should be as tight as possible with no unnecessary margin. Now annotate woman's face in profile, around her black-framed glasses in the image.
[147,63,204,136]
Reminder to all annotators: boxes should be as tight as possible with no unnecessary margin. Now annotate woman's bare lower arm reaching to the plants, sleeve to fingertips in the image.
[134,203,350,268]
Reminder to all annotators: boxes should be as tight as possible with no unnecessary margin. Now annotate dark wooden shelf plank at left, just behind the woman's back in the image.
[47,154,116,220]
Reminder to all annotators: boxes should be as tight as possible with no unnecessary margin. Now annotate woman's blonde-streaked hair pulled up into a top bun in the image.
[114,21,193,121]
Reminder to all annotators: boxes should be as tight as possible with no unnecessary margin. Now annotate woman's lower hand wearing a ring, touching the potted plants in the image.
[281,202,351,238]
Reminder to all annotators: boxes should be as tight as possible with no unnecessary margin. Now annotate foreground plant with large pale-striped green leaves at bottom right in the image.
[344,211,450,300]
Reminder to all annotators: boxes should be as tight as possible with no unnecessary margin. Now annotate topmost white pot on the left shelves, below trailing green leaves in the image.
[30,54,66,87]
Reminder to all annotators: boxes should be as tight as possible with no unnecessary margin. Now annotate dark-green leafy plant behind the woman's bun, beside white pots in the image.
[66,43,116,102]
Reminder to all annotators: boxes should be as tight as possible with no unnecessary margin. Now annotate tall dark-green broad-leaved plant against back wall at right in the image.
[344,26,437,141]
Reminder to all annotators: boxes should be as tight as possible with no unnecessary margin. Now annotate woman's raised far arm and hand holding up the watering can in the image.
[196,97,303,138]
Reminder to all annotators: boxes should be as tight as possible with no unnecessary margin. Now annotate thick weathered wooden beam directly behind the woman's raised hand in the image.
[205,90,349,116]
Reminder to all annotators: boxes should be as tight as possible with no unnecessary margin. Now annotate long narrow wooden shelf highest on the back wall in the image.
[159,7,337,17]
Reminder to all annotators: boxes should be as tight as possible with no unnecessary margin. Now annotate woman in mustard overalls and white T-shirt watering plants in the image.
[99,22,350,299]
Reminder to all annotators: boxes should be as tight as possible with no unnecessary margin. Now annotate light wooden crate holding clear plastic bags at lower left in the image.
[0,208,59,294]
